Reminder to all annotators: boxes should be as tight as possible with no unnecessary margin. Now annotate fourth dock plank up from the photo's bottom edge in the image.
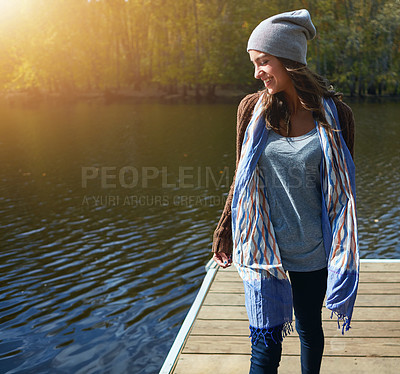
[197,305,400,322]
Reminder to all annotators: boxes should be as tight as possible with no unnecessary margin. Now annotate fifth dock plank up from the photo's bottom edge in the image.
[204,292,400,307]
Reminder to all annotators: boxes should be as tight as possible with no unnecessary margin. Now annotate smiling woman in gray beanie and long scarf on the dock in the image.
[213,9,359,374]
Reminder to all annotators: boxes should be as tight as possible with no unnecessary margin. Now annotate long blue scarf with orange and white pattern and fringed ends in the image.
[232,96,359,340]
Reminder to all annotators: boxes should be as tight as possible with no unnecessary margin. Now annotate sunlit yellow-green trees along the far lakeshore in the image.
[0,0,400,96]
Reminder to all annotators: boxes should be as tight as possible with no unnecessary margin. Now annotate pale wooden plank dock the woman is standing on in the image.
[160,260,400,374]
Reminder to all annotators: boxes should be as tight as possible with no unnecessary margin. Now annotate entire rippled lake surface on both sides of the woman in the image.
[0,98,400,374]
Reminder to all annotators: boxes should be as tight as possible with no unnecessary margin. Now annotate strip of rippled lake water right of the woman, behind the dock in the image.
[352,102,400,258]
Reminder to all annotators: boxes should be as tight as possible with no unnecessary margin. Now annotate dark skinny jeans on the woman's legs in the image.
[250,268,328,374]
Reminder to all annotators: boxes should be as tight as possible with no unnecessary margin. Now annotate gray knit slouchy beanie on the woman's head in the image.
[247,9,316,65]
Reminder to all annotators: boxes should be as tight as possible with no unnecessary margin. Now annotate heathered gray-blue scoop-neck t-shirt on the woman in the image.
[258,128,326,271]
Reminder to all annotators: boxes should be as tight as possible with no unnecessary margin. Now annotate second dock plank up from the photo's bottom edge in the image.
[185,335,400,357]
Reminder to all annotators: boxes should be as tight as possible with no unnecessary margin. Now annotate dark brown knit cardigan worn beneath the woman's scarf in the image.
[212,92,354,254]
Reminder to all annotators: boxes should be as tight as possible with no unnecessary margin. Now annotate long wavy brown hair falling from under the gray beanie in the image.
[263,57,342,136]
